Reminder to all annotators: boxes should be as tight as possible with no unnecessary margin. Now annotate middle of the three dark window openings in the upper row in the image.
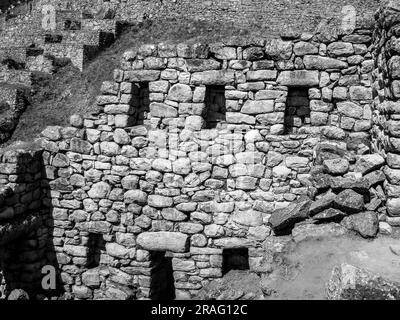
[205,86,226,129]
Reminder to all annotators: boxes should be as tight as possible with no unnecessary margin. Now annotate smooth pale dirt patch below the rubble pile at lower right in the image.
[267,233,400,300]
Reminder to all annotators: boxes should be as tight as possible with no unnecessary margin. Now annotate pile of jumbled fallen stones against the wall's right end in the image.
[269,152,386,238]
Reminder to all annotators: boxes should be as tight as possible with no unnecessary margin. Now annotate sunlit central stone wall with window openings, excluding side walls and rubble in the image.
[25,20,384,299]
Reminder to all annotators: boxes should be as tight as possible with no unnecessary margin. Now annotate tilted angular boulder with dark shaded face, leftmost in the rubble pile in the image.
[269,199,311,233]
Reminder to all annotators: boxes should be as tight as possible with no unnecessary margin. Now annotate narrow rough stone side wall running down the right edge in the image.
[372,1,400,225]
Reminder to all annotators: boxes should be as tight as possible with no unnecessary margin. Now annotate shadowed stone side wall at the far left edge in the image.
[0,147,50,298]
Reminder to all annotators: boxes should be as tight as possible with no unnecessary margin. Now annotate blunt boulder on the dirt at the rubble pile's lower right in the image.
[342,211,379,238]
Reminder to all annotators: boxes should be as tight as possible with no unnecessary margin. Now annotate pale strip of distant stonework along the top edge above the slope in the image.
[29,0,379,36]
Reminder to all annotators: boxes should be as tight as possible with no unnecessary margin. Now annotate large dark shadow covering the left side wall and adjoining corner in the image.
[0,146,64,300]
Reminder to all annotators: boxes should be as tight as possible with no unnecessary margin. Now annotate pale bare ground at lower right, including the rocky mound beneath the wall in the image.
[198,229,400,300]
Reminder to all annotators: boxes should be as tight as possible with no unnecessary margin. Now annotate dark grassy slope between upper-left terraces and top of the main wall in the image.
[6,20,252,145]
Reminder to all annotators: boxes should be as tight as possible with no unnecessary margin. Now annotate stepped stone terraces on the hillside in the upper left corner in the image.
[0,1,120,143]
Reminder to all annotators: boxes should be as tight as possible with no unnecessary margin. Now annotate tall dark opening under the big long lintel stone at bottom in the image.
[150,251,175,300]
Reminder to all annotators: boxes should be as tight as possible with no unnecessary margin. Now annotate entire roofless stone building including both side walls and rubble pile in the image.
[0,1,400,299]
